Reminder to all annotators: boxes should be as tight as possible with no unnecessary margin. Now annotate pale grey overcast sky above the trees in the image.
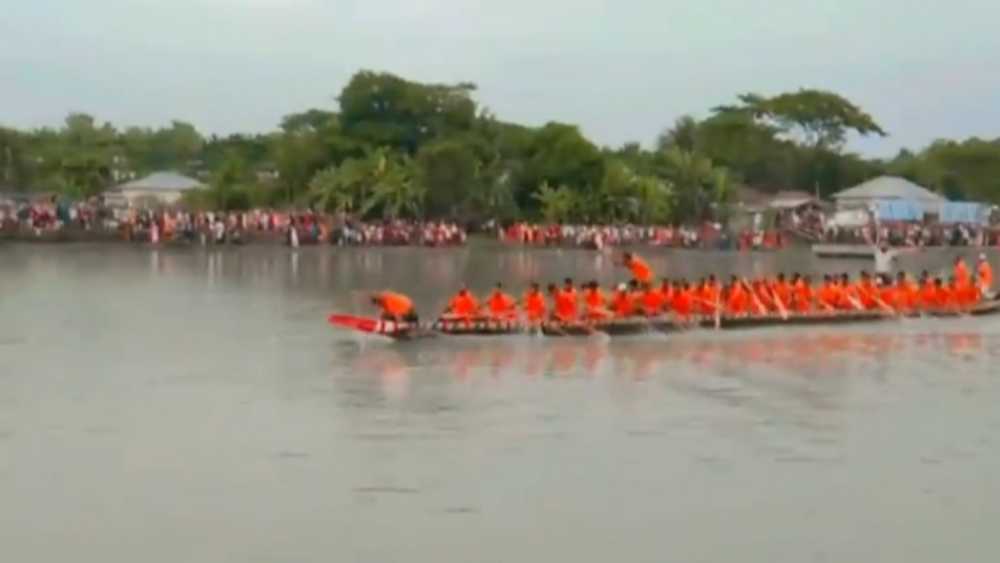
[0,0,1000,155]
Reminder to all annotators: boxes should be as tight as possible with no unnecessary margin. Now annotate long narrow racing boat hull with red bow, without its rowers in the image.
[327,299,1000,340]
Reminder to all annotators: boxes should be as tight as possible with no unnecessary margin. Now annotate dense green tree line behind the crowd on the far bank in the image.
[0,71,1000,222]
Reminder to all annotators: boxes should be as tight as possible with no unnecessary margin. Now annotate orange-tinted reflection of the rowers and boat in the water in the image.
[347,330,996,392]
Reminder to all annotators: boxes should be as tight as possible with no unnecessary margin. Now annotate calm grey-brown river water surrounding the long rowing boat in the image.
[0,244,1000,563]
